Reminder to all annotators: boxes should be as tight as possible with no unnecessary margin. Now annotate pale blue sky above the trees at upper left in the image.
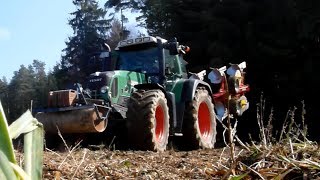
[0,0,142,81]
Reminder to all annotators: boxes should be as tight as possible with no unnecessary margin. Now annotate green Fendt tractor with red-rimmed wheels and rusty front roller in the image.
[36,36,216,151]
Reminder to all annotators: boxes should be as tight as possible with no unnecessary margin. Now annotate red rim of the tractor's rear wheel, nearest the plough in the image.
[198,102,211,140]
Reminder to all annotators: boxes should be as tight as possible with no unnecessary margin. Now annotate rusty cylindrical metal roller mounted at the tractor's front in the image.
[35,108,107,134]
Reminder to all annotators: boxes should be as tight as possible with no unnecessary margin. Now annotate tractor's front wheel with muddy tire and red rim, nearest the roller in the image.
[127,90,169,151]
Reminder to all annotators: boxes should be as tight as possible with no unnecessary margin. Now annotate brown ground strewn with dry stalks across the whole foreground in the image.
[16,136,320,180]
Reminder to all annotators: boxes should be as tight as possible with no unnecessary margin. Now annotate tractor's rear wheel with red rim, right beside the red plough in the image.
[183,87,216,149]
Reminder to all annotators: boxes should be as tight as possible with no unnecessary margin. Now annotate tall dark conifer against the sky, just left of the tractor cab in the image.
[54,0,110,87]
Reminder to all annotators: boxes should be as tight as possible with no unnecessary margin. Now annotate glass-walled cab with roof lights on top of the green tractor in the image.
[115,36,187,88]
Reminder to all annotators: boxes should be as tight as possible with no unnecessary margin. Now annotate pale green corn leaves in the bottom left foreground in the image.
[0,102,44,180]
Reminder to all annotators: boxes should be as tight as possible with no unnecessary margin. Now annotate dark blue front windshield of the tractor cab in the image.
[117,47,160,74]
